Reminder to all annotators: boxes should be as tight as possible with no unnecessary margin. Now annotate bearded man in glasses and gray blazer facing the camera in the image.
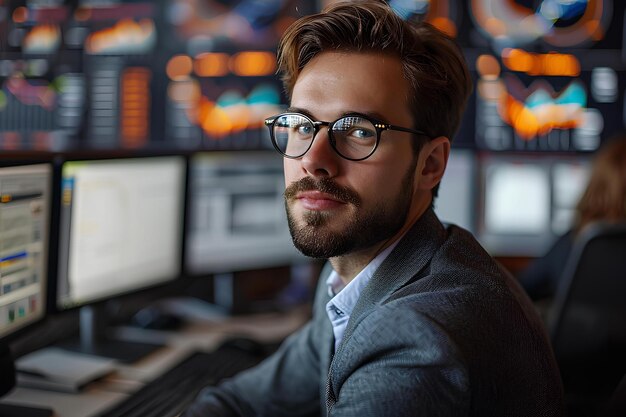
[185,2,563,417]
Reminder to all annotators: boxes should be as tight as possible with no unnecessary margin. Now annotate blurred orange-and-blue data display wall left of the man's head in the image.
[0,0,317,150]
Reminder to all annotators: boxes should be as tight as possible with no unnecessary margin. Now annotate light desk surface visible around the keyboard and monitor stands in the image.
[0,307,310,417]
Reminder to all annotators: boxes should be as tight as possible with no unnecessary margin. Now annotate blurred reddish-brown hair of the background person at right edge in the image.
[575,136,626,232]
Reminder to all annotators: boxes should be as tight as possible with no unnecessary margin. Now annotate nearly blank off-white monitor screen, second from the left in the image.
[57,156,186,309]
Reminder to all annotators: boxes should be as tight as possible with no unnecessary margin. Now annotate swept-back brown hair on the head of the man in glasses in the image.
[278,1,472,141]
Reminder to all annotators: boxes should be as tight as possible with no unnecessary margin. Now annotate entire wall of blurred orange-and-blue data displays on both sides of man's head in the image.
[0,0,626,152]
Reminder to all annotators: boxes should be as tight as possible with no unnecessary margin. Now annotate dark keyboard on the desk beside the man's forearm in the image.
[98,347,263,417]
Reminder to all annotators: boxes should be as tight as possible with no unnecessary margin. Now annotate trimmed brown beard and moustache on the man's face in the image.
[285,156,417,258]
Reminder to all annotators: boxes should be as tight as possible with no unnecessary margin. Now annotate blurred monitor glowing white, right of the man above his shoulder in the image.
[478,154,589,257]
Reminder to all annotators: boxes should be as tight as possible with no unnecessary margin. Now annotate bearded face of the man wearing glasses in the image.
[285,52,430,258]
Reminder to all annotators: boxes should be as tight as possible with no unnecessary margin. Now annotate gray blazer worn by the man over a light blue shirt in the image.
[184,210,564,417]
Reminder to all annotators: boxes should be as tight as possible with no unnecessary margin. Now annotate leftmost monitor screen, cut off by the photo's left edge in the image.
[0,164,52,339]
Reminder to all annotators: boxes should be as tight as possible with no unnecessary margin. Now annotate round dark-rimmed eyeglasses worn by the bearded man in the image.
[265,113,428,161]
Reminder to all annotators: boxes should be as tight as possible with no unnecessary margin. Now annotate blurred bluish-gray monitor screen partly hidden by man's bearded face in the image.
[185,152,302,275]
